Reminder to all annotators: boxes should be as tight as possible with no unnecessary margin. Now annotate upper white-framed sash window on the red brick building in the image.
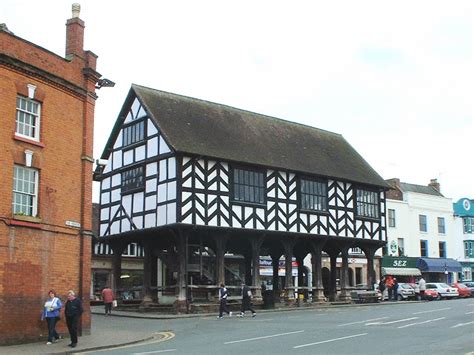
[15,96,41,141]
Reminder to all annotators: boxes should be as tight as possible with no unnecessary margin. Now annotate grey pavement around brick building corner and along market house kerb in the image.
[0,301,404,355]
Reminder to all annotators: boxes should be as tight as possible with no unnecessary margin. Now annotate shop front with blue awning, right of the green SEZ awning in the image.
[416,258,462,285]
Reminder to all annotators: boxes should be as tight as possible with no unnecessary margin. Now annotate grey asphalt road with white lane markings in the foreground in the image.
[83,298,474,355]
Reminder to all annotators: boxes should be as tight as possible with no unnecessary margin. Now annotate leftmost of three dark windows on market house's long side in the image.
[233,169,265,204]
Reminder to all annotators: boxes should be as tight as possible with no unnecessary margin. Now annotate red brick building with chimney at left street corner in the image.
[0,5,100,345]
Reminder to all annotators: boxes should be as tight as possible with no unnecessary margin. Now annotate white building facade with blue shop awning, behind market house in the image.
[385,179,461,282]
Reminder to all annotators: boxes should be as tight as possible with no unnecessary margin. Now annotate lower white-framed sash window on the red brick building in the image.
[13,165,38,217]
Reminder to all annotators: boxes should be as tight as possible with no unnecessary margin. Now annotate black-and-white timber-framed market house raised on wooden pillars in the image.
[95,85,388,312]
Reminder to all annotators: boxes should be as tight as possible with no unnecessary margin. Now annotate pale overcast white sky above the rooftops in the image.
[4,0,474,201]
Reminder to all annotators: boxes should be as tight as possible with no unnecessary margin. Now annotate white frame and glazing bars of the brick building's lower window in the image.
[12,165,39,217]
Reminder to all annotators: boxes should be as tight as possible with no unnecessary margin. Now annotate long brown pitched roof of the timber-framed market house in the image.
[103,84,388,189]
